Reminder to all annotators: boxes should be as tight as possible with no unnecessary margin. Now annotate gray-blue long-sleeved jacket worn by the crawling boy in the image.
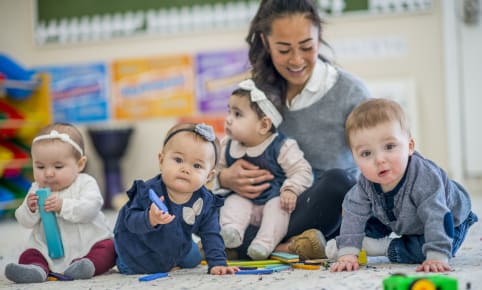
[336,152,471,259]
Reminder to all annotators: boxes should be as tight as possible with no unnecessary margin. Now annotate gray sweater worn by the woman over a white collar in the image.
[279,69,370,177]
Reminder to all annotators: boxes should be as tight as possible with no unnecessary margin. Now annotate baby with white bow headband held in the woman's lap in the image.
[214,79,313,260]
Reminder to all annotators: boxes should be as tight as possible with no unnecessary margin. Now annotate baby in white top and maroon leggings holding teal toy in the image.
[5,123,116,283]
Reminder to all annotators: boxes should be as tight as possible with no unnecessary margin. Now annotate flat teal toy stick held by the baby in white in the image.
[37,188,64,259]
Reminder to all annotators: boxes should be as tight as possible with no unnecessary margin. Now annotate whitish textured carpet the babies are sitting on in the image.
[0,191,482,290]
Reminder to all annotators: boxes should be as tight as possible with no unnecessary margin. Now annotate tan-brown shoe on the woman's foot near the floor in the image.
[288,229,326,260]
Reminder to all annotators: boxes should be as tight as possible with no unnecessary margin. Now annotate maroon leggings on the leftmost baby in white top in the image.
[18,240,116,276]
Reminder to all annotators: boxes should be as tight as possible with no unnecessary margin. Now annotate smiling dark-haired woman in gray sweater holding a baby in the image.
[218,0,369,258]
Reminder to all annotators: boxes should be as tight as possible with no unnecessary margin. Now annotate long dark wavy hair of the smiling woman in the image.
[246,0,327,103]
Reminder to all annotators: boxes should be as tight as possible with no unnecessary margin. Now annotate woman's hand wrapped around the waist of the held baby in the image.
[218,159,274,199]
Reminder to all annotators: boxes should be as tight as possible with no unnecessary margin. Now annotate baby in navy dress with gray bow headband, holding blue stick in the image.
[114,123,239,275]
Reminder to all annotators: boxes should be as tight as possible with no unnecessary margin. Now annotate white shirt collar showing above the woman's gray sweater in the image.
[286,59,338,111]
